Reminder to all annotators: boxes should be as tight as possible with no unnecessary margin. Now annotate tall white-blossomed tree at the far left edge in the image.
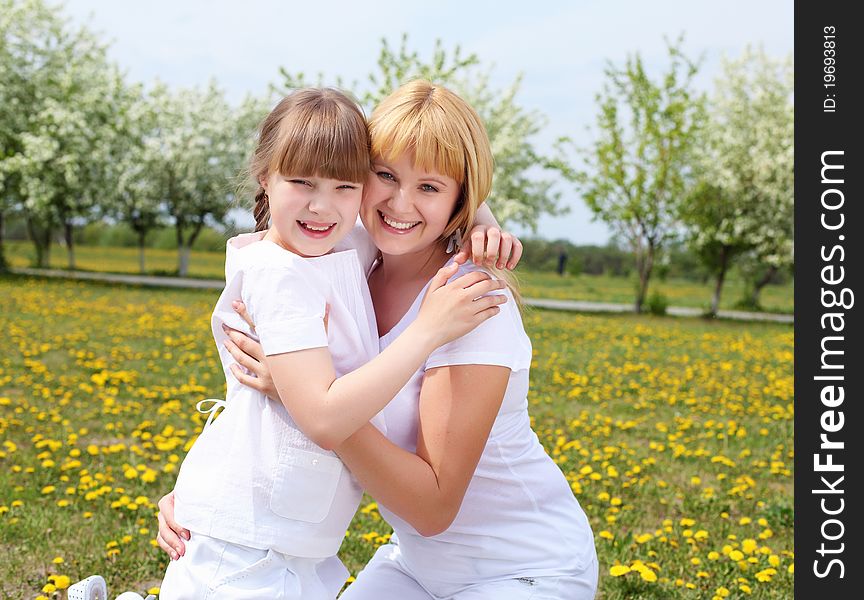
[2,0,123,268]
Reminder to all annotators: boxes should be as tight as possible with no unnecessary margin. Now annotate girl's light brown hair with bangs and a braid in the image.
[248,88,372,231]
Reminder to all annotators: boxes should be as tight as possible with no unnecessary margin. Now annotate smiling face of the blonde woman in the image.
[360,154,460,256]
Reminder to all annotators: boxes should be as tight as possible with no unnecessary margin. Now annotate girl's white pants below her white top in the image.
[159,532,348,600]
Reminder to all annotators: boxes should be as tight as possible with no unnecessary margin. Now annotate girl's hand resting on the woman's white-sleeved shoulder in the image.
[410,262,507,348]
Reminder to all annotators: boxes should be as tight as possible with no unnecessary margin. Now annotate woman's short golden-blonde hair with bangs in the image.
[369,79,521,305]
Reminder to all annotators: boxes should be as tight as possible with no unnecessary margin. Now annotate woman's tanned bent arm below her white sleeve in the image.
[336,365,510,536]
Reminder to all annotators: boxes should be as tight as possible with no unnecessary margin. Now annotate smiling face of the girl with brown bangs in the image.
[261,173,363,256]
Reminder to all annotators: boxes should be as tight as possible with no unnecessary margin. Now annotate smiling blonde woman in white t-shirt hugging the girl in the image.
[160,81,597,600]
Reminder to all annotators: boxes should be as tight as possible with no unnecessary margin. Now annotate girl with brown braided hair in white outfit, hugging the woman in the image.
[161,89,506,600]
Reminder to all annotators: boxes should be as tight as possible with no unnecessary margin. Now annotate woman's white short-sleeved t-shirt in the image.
[379,263,596,597]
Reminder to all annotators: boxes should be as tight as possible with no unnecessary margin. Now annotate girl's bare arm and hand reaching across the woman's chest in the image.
[259,264,506,450]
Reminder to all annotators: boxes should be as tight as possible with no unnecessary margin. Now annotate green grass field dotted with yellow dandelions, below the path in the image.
[0,277,794,600]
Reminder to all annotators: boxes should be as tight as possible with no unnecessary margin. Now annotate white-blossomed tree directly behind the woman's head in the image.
[276,34,567,231]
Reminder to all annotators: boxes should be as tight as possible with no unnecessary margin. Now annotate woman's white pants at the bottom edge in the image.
[339,544,598,600]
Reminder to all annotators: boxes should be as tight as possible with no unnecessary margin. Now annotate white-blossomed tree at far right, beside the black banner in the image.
[682,48,793,315]
